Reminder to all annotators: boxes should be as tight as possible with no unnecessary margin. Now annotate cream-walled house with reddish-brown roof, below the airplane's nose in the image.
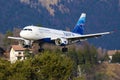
[10,45,32,63]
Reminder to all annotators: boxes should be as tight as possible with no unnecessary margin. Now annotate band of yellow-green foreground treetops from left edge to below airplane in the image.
[0,52,74,80]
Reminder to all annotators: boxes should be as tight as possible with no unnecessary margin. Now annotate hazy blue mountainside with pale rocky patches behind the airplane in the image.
[0,0,120,49]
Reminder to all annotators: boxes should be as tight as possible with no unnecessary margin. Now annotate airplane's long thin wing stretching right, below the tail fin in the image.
[67,32,111,40]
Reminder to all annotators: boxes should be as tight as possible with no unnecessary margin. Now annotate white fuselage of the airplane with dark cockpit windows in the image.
[20,26,80,40]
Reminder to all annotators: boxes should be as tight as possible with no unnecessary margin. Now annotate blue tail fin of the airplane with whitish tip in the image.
[72,13,86,34]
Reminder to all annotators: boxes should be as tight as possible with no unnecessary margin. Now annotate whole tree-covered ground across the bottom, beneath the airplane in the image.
[0,43,120,80]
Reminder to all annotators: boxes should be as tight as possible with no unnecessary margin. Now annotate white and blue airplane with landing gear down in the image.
[8,13,111,52]
